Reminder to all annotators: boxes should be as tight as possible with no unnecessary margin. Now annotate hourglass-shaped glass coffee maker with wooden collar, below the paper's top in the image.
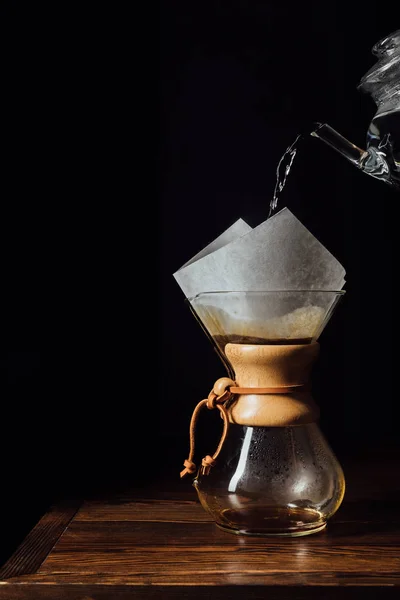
[186,290,345,536]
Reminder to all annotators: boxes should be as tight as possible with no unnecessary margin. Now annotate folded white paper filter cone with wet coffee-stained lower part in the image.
[174,208,345,350]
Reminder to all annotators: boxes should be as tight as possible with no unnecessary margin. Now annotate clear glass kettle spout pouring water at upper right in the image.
[311,123,398,185]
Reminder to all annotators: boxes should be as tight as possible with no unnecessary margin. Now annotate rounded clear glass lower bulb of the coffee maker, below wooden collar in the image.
[194,423,345,537]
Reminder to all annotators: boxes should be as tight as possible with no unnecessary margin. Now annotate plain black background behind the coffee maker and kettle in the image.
[0,0,399,559]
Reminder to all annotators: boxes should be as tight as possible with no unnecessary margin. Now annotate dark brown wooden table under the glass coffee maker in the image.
[0,460,400,600]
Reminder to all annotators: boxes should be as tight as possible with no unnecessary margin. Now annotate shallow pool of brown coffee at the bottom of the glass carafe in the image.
[216,506,326,537]
